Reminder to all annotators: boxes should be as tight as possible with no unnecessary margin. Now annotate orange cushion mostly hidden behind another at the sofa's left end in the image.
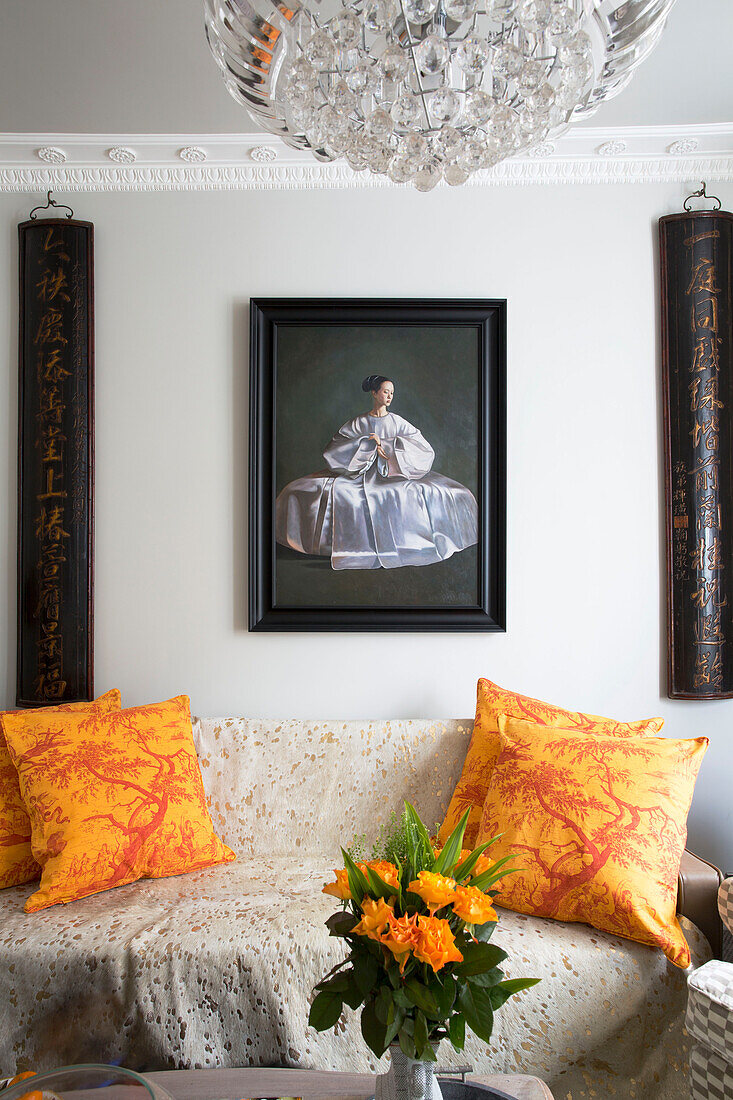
[0,691,122,890]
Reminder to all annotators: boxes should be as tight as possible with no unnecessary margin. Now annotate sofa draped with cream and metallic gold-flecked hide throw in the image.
[0,718,719,1100]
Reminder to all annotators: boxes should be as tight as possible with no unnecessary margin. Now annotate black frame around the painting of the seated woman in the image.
[249,298,506,633]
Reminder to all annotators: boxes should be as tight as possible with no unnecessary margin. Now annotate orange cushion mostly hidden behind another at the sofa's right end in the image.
[438,680,664,848]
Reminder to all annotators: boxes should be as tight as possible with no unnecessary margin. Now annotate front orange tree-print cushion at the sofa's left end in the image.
[3,695,234,913]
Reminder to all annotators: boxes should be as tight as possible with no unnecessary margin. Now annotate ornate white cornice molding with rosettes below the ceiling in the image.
[0,122,733,191]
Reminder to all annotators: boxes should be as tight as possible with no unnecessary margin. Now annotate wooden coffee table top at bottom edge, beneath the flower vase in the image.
[145,1069,553,1100]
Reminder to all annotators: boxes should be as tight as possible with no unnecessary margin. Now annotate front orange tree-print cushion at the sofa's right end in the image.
[471,715,708,967]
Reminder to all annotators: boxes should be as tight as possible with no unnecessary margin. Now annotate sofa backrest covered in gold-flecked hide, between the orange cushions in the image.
[194,718,473,866]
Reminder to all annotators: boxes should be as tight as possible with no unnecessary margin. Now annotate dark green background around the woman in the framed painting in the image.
[275,325,479,607]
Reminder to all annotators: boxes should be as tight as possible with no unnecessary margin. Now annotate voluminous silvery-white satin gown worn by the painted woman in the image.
[275,413,479,569]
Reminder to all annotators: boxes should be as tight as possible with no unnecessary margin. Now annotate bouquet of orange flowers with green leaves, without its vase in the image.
[309,803,539,1062]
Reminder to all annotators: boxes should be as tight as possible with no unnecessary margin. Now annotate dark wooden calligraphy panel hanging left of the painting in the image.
[17,218,94,706]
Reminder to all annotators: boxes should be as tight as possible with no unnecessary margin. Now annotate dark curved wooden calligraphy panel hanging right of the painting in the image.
[659,210,733,699]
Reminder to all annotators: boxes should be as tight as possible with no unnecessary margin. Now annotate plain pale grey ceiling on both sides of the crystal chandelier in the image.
[0,0,733,134]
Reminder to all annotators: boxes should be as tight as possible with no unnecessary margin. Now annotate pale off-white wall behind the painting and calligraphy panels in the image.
[0,178,733,868]
